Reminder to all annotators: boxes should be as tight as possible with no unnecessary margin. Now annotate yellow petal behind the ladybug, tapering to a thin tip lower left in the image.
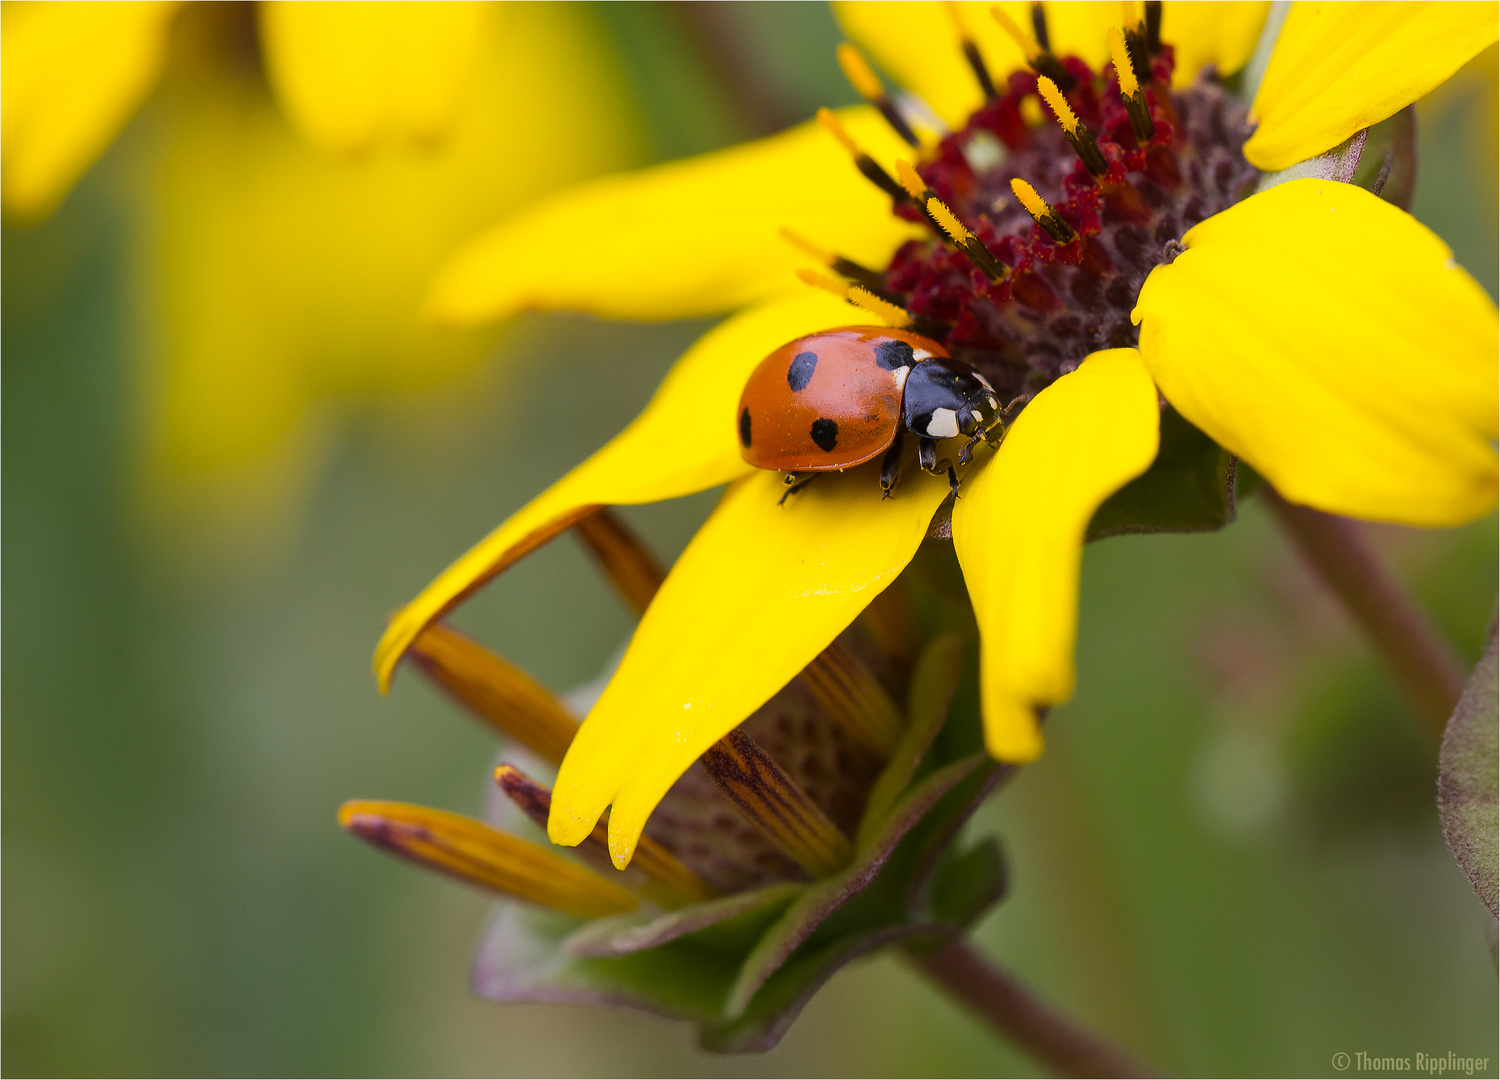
[375,290,851,692]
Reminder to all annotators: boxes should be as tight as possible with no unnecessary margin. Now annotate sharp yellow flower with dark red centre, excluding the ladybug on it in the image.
[375,3,1497,867]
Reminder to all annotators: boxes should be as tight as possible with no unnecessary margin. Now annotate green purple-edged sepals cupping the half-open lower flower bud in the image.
[474,657,1011,1053]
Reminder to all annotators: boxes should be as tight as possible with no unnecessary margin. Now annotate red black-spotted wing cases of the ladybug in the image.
[735,327,948,473]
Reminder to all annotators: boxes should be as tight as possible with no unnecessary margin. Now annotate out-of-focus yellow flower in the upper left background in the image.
[0,2,636,551]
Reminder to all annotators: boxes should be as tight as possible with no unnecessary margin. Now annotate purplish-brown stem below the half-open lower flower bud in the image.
[908,941,1157,1077]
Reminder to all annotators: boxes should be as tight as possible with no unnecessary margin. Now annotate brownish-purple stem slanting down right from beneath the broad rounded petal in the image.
[1262,485,1464,740]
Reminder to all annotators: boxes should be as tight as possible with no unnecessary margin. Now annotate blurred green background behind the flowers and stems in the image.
[0,3,1500,1076]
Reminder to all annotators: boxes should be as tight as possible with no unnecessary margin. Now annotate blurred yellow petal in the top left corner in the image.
[0,0,179,218]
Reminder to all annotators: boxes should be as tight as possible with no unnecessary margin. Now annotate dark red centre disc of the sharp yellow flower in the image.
[881,45,1259,396]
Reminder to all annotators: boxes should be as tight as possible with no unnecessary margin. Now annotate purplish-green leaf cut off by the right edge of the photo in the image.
[1437,620,1500,917]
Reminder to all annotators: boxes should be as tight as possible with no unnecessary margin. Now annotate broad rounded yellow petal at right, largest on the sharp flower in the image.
[1133,179,1500,525]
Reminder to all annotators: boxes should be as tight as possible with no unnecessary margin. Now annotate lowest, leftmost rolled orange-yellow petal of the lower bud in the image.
[339,800,641,918]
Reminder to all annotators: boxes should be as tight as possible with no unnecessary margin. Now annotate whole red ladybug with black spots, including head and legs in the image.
[737,327,1008,503]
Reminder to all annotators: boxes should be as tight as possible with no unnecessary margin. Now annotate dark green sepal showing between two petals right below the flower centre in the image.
[1088,407,1235,540]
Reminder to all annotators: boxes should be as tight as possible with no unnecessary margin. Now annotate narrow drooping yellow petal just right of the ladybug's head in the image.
[953,350,1160,761]
